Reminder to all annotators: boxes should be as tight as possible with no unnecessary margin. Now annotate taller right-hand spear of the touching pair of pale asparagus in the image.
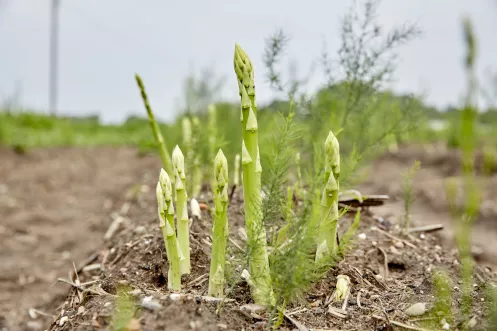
[173,145,190,275]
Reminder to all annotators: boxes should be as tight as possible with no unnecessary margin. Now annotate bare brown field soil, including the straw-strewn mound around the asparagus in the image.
[0,145,497,331]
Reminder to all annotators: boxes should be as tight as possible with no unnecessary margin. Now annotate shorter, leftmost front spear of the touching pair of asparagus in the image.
[156,169,181,291]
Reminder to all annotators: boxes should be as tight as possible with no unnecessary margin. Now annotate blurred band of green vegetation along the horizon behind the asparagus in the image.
[0,87,497,164]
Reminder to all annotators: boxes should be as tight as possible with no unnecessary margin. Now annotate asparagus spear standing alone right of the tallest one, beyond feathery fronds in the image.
[316,131,340,260]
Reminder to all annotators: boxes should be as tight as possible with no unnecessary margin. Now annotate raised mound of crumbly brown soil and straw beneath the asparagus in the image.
[44,184,492,330]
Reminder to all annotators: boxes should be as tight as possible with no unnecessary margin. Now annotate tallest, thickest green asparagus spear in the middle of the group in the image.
[234,44,274,304]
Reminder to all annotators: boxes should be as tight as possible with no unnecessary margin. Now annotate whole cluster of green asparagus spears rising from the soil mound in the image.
[136,44,340,305]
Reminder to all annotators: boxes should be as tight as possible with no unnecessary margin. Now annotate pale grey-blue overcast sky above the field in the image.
[0,0,497,122]
